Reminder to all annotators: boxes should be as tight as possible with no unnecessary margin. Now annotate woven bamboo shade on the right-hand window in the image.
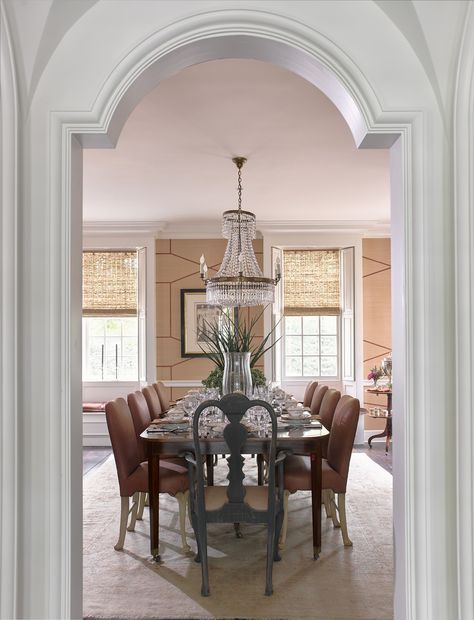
[283,250,341,316]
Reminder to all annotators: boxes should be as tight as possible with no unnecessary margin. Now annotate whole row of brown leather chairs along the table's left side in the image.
[105,382,189,551]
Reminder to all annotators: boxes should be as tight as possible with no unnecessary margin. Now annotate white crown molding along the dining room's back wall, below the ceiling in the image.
[83,220,391,239]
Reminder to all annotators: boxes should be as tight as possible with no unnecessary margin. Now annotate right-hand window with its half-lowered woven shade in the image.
[282,250,341,379]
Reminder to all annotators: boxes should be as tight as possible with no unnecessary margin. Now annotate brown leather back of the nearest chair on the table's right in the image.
[327,396,360,493]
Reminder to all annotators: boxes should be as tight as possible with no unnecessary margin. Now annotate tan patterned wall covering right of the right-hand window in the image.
[362,239,392,429]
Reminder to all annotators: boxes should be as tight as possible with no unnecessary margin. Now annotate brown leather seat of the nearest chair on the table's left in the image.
[120,457,188,497]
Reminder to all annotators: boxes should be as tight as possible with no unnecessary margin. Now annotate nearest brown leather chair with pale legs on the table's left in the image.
[105,398,189,552]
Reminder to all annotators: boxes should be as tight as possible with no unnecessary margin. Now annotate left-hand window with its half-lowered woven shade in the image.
[82,250,140,381]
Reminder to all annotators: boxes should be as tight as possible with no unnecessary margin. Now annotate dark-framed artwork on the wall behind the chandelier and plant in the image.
[181,288,222,357]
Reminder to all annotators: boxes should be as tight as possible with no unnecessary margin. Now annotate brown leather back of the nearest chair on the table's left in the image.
[105,398,140,497]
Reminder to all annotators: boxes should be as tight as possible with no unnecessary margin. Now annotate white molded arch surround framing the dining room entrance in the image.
[13,6,456,620]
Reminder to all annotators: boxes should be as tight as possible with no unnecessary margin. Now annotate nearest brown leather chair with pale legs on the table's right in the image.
[280,396,360,547]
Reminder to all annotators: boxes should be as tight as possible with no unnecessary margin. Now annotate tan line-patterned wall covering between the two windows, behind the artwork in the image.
[156,239,263,399]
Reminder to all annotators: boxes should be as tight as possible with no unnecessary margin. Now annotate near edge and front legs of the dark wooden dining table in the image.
[141,424,329,561]
